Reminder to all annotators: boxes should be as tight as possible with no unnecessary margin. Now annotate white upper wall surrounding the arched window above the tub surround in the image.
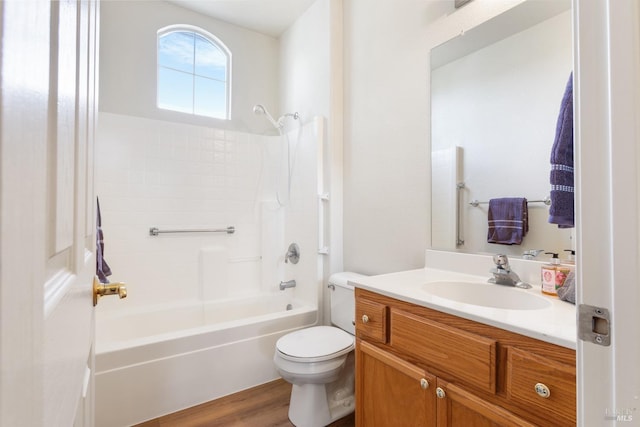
[100,0,279,133]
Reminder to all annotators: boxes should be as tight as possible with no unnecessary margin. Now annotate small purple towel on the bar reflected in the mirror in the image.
[487,197,529,245]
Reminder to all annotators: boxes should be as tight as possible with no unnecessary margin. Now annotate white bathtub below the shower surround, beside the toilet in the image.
[95,292,318,427]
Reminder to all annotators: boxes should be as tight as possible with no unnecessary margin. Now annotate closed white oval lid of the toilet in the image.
[276,326,353,359]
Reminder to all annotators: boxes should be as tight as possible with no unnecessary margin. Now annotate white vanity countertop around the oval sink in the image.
[349,268,577,350]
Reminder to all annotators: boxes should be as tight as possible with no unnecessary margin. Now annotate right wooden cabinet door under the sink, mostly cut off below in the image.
[436,378,535,427]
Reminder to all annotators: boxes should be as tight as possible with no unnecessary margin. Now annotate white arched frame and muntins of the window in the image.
[155,24,233,120]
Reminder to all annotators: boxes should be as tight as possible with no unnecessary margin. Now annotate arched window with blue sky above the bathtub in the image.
[157,26,231,120]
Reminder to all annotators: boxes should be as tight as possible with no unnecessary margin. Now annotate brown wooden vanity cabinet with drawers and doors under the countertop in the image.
[356,288,576,427]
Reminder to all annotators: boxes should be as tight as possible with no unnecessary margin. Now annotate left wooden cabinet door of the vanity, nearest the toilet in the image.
[356,340,436,427]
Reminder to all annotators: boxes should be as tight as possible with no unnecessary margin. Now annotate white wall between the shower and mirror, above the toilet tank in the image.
[344,0,520,274]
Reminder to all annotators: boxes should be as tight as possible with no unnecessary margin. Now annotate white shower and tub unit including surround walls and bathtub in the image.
[95,111,328,427]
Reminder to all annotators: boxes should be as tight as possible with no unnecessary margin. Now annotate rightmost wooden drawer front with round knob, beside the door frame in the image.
[506,347,576,425]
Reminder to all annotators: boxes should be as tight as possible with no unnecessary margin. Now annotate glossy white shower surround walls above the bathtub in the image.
[95,113,323,310]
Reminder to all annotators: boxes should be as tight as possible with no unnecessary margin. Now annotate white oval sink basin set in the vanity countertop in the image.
[423,281,551,310]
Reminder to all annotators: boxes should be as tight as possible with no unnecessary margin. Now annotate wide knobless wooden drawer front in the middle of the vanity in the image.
[390,309,496,393]
